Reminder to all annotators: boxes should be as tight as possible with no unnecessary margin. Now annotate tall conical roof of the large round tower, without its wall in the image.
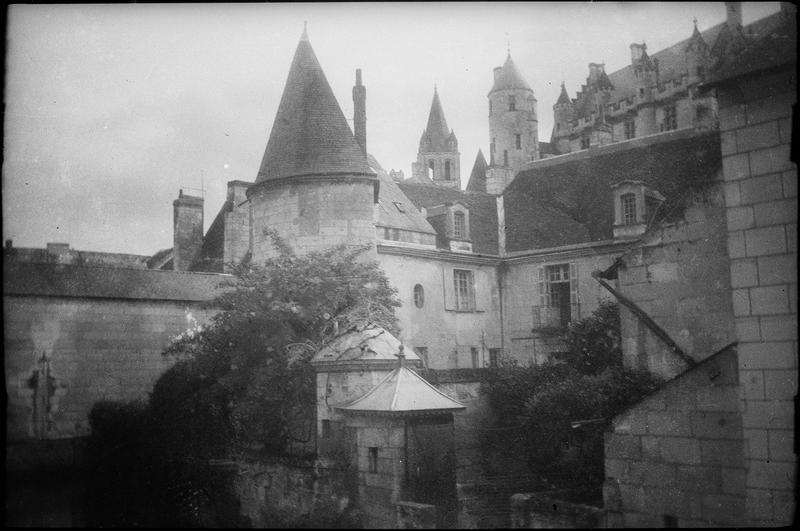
[256,30,372,183]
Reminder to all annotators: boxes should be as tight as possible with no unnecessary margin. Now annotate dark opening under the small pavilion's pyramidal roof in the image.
[406,415,458,529]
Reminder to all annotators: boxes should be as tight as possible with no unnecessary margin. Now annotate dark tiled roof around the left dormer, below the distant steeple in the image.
[398,181,497,255]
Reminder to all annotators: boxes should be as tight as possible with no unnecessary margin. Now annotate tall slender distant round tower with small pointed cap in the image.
[486,53,539,194]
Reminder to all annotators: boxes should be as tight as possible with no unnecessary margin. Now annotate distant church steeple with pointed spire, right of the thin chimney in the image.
[411,87,461,190]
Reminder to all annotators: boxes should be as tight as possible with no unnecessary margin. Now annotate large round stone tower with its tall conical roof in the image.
[247,26,378,261]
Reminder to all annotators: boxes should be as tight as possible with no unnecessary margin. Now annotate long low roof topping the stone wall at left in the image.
[3,260,230,302]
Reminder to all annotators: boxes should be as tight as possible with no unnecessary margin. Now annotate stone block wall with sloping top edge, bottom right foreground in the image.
[603,349,746,527]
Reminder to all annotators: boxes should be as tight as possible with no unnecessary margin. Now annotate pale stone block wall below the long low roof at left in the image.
[3,295,214,442]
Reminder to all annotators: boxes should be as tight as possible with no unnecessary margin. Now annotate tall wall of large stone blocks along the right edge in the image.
[717,64,798,525]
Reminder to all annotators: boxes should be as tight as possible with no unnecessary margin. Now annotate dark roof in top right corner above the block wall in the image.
[709,9,797,84]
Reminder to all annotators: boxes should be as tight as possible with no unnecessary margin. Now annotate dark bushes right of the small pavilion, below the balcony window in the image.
[481,303,660,502]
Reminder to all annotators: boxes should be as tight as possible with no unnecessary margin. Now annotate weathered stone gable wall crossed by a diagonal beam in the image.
[618,186,735,378]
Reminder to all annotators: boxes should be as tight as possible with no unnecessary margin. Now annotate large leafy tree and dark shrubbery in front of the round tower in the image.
[90,235,399,525]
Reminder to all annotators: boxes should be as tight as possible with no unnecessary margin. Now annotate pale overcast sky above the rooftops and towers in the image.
[3,2,779,254]
